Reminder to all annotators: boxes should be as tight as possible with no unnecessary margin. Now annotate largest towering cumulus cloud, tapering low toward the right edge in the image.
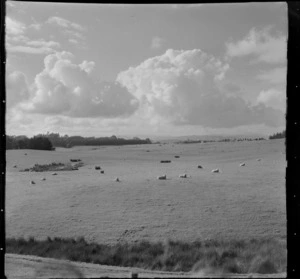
[117,49,284,128]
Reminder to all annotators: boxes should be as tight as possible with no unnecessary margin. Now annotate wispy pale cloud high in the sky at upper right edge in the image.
[226,28,287,63]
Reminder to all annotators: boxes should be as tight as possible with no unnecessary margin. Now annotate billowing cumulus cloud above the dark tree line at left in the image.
[22,52,138,117]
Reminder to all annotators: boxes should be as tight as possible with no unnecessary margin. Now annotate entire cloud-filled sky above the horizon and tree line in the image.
[6,2,287,137]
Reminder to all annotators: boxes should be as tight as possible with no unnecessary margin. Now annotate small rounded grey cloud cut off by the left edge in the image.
[5,71,29,108]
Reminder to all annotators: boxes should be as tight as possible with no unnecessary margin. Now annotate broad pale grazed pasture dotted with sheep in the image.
[6,140,286,244]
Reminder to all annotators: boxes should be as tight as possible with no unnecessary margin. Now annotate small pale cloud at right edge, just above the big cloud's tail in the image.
[257,88,286,111]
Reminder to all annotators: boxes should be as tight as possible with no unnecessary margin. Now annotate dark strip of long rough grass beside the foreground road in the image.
[6,237,287,274]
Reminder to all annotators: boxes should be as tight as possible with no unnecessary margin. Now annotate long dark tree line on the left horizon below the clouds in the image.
[6,132,152,150]
